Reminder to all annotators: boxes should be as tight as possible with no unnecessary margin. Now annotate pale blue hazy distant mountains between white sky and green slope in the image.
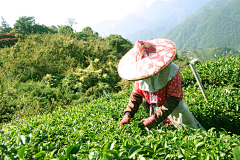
[92,0,211,43]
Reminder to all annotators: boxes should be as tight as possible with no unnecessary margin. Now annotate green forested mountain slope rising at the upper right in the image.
[161,0,240,50]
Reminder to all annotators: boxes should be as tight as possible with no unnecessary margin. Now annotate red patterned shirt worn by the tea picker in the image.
[132,70,183,106]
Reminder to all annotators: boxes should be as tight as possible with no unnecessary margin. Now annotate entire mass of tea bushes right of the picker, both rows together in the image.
[181,56,240,134]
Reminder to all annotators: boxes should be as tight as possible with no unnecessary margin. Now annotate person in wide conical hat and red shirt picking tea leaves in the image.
[118,39,204,129]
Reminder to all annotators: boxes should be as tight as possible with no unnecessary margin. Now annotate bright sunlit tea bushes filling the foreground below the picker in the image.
[0,88,240,160]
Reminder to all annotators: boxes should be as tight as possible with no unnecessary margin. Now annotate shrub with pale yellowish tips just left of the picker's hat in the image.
[72,59,121,102]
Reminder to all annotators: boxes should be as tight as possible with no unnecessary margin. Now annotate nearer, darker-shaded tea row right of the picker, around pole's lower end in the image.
[184,85,240,135]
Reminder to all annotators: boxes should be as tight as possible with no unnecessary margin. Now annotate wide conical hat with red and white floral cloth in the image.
[118,39,177,80]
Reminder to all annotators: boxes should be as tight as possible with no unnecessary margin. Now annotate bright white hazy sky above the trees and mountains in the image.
[0,0,156,31]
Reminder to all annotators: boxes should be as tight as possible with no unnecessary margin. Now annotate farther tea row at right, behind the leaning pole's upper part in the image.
[181,55,240,88]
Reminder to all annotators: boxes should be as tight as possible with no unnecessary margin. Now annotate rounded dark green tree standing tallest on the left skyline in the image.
[14,16,35,35]
